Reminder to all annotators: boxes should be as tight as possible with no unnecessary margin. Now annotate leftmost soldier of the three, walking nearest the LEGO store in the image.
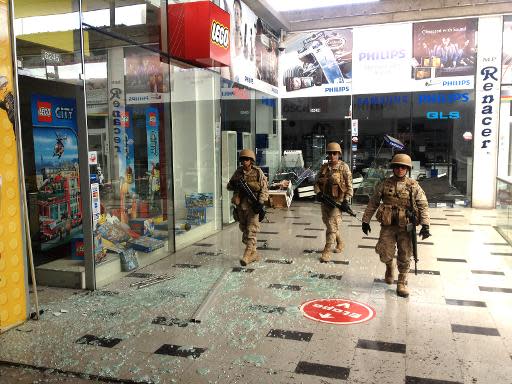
[227,149,268,266]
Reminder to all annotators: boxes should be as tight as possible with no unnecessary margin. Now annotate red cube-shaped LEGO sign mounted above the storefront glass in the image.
[167,1,230,68]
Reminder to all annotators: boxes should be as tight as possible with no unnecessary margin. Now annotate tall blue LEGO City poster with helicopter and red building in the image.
[31,94,82,250]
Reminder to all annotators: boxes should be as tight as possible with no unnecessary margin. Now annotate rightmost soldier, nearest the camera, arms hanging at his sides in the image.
[361,153,431,297]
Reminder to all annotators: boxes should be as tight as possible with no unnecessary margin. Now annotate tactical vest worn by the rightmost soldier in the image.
[375,178,419,227]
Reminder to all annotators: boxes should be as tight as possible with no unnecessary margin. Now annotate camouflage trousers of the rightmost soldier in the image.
[375,225,412,273]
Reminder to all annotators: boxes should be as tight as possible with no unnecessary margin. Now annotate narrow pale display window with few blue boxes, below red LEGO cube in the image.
[171,65,221,249]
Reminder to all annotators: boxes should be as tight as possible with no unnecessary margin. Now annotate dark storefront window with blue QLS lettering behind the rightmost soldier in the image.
[352,90,475,206]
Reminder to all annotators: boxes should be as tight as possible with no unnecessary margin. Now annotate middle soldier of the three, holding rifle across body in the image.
[315,142,353,263]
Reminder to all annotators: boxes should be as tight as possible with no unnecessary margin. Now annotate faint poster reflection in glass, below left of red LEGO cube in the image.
[124,48,170,104]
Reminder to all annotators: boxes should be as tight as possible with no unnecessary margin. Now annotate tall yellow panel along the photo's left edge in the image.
[0,0,27,333]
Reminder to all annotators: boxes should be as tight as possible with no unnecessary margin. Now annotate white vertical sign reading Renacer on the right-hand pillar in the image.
[472,16,503,209]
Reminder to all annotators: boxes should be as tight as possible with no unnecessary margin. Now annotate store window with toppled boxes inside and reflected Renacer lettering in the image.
[84,2,174,286]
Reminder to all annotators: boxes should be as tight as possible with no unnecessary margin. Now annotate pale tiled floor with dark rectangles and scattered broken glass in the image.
[0,202,512,384]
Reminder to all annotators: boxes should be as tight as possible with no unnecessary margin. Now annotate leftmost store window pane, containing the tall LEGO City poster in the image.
[13,0,84,288]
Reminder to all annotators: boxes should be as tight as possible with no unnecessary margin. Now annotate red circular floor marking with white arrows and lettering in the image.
[300,299,375,324]
